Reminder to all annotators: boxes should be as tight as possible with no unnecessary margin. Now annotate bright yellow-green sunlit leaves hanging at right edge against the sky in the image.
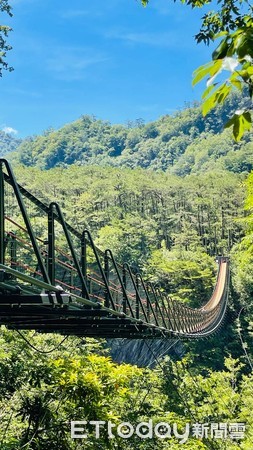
[193,15,253,141]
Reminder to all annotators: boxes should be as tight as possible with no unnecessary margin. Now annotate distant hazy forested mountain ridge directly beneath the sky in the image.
[13,93,253,176]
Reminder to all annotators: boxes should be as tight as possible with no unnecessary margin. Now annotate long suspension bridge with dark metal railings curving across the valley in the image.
[0,159,229,339]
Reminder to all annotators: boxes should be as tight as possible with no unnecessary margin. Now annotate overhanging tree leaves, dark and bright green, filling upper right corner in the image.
[142,0,253,141]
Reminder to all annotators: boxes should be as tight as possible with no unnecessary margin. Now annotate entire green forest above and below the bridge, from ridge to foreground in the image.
[0,97,253,450]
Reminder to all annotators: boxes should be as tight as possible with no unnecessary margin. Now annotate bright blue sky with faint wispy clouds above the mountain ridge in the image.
[0,0,214,137]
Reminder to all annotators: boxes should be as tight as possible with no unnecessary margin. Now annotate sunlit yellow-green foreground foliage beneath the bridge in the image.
[0,327,253,450]
